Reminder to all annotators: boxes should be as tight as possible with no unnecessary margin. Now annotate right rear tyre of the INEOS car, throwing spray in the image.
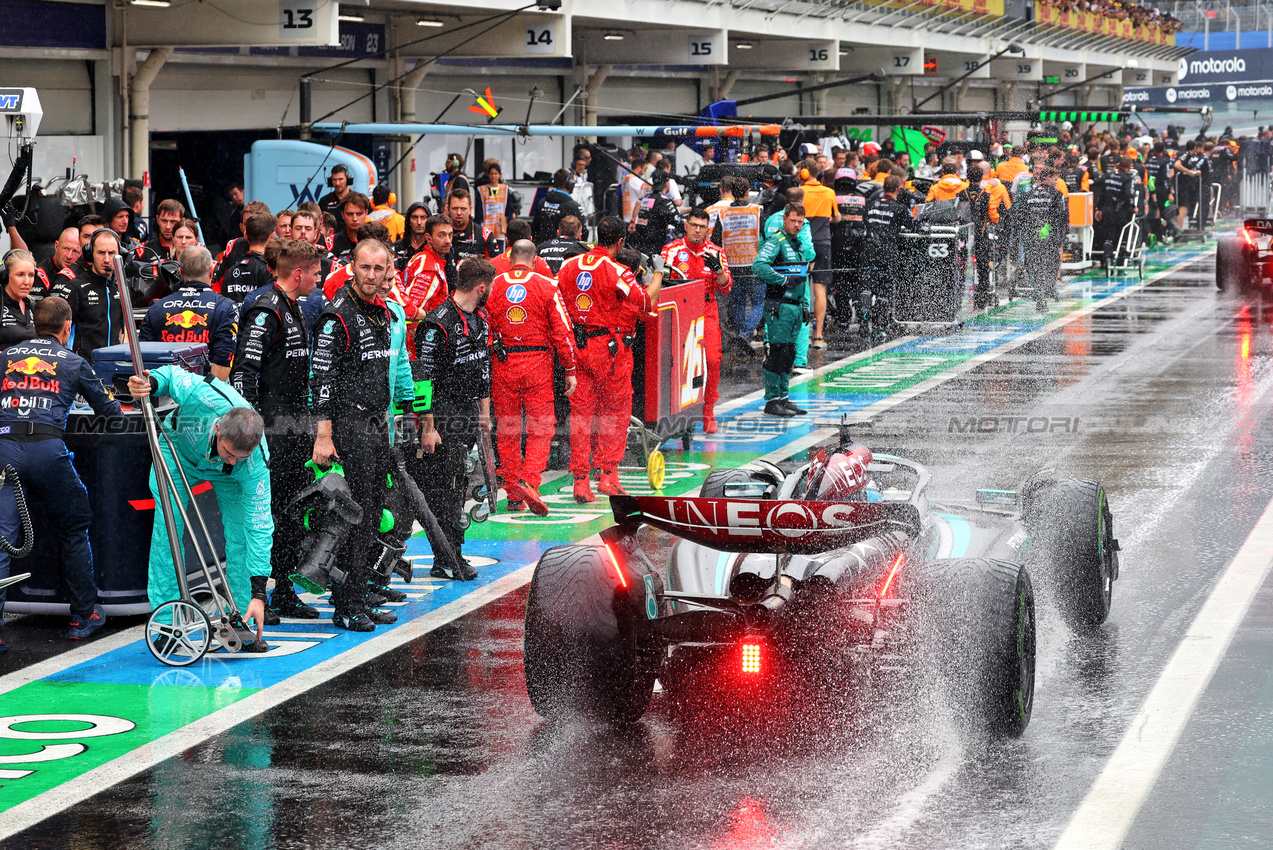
[919,557,1036,738]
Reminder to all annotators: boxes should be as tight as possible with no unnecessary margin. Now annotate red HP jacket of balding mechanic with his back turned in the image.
[486,266,574,371]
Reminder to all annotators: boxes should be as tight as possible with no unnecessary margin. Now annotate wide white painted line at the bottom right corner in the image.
[1055,493,1273,850]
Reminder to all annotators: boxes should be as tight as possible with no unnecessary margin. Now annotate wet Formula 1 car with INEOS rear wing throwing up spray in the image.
[524,419,1118,737]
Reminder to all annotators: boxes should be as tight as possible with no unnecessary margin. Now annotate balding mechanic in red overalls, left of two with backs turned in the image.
[486,240,577,517]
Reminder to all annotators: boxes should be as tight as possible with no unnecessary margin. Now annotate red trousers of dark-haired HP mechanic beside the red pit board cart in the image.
[570,336,633,477]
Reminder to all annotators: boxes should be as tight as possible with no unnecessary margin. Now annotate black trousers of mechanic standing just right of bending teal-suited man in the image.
[265,416,314,603]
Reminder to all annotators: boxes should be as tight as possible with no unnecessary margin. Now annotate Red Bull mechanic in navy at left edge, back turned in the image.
[0,295,121,640]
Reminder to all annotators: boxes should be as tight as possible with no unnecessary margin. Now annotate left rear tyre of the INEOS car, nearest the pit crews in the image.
[524,546,658,724]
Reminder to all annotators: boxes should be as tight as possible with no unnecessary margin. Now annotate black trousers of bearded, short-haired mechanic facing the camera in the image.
[331,419,390,612]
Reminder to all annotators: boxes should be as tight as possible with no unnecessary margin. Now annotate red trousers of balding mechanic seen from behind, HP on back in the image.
[490,351,556,487]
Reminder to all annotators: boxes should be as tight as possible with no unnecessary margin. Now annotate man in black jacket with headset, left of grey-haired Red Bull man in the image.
[52,228,123,363]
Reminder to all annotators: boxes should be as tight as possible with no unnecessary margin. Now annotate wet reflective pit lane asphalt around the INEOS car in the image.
[6,258,1273,847]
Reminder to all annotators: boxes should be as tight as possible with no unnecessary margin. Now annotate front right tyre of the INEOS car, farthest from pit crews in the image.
[1026,478,1118,626]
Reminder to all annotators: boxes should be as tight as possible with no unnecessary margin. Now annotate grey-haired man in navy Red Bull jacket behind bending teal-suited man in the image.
[139,246,238,380]
